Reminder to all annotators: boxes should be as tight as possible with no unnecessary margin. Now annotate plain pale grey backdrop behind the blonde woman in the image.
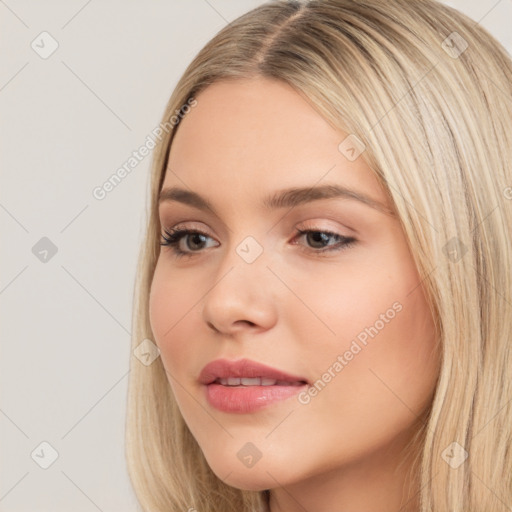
[0,0,512,512]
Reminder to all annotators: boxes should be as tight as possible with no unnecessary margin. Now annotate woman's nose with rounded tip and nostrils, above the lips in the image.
[202,244,278,335]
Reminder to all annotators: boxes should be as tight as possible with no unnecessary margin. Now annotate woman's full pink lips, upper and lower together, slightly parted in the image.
[199,359,308,413]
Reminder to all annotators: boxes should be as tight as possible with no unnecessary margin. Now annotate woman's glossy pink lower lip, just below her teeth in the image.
[206,383,307,413]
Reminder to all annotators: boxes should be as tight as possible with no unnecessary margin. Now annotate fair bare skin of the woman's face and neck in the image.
[150,78,439,512]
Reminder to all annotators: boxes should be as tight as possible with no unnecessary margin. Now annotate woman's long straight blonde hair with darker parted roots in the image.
[126,0,512,512]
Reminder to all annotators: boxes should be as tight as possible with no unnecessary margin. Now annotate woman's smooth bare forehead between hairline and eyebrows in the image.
[164,78,385,208]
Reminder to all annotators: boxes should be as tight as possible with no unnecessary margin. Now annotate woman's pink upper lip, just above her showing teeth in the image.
[199,359,307,384]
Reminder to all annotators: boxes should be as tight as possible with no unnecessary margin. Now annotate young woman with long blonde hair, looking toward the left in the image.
[127,0,512,512]
